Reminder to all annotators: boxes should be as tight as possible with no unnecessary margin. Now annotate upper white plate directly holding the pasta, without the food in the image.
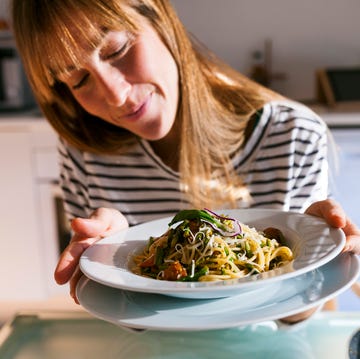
[80,209,345,299]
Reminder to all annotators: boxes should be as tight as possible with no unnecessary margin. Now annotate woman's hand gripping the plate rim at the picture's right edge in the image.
[305,199,360,255]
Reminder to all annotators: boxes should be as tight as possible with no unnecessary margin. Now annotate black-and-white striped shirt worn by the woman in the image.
[58,101,328,225]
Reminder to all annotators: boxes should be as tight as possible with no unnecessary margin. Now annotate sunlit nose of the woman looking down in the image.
[98,68,131,107]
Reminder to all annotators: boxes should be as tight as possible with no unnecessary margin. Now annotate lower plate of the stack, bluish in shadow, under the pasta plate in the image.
[77,253,360,331]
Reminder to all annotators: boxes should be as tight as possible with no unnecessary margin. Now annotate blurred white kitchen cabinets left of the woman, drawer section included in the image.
[0,118,64,300]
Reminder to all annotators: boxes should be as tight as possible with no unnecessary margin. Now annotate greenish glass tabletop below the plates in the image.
[0,311,360,359]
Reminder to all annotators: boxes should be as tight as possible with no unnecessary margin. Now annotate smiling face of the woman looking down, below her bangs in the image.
[59,25,179,140]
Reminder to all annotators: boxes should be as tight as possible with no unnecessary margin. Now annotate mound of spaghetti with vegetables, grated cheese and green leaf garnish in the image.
[134,209,293,281]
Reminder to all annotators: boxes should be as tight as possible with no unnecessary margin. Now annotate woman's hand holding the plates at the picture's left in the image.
[54,208,129,303]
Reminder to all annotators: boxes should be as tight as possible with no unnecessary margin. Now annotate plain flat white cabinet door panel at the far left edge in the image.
[0,130,43,299]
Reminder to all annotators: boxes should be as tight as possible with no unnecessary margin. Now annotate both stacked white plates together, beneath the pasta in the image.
[77,209,360,331]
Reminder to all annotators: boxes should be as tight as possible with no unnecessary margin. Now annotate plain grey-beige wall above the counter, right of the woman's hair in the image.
[172,0,360,99]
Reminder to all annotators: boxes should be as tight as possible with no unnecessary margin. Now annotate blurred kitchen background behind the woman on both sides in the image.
[0,0,360,323]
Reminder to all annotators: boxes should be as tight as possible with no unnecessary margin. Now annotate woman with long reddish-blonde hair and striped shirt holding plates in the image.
[13,0,359,320]
